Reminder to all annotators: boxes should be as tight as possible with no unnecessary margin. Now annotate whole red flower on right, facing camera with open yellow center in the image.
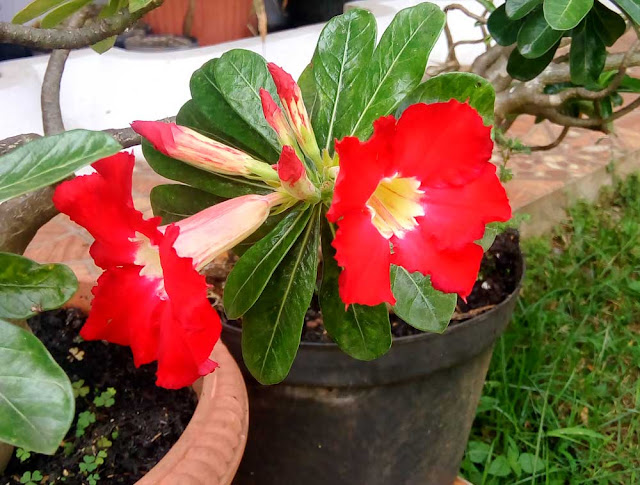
[327,100,511,305]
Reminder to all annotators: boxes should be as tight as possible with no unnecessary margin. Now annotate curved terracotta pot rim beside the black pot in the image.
[137,342,249,485]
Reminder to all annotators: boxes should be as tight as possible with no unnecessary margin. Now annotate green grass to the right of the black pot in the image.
[461,176,640,485]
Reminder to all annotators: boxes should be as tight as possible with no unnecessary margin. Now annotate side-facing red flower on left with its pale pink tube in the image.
[53,153,281,389]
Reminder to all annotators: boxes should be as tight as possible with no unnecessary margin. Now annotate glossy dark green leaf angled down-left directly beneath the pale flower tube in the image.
[224,208,311,319]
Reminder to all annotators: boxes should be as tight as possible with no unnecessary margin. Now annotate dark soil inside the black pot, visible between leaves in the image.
[221,230,522,343]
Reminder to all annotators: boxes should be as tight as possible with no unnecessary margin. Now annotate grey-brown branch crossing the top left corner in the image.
[0,0,164,49]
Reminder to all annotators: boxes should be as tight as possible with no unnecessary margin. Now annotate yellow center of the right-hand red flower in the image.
[367,174,424,239]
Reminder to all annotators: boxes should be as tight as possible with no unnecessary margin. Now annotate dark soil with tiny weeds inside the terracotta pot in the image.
[0,310,197,485]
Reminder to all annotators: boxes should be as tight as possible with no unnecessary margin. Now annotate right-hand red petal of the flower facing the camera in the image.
[418,162,511,248]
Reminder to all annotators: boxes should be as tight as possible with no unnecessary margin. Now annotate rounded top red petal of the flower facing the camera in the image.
[394,99,493,187]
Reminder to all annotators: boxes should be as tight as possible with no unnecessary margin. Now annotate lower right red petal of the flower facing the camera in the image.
[391,227,484,298]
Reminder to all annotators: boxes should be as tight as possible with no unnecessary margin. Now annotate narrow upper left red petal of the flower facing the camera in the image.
[327,116,395,222]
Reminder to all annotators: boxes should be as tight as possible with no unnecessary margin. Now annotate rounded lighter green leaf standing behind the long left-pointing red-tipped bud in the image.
[214,49,280,161]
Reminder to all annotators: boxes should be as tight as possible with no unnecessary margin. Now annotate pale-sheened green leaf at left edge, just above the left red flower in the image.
[0,130,122,202]
